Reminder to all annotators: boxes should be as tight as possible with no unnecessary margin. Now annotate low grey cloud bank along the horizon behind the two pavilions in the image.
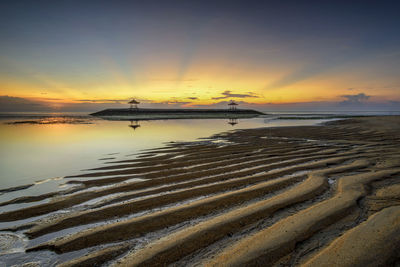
[0,92,400,113]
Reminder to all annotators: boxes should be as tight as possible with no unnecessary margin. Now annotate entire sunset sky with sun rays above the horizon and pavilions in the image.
[0,0,400,112]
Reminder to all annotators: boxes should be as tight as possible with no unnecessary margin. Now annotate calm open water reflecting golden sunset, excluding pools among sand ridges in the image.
[0,113,398,195]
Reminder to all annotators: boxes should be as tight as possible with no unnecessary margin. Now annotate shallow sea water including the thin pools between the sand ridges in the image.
[0,114,398,266]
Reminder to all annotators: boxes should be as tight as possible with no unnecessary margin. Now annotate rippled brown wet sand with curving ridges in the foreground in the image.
[0,116,400,266]
